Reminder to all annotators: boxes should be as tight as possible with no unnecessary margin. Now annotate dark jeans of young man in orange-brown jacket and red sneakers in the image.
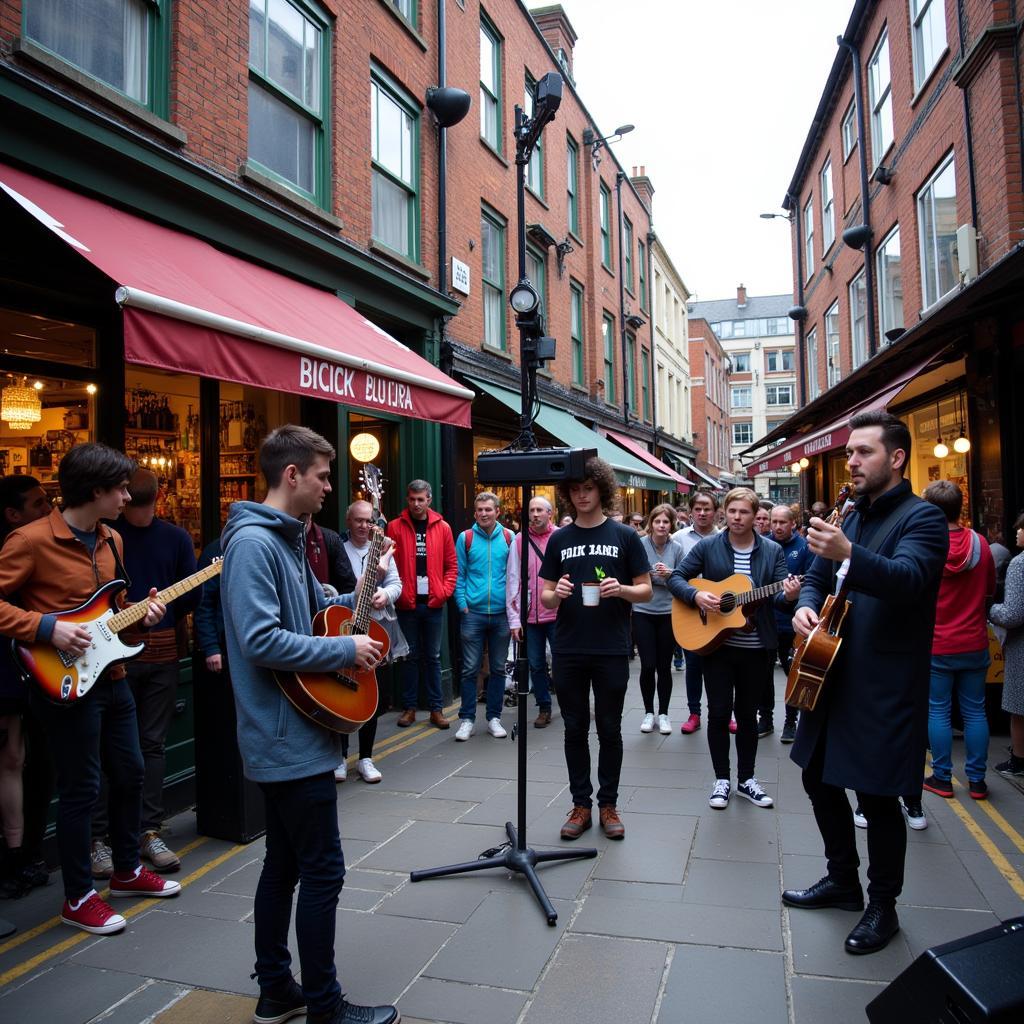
[32,679,142,900]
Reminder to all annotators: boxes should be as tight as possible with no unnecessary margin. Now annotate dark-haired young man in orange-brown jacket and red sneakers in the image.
[0,444,181,935]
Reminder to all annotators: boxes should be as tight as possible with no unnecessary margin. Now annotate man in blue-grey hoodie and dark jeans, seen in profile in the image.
[221,425,400,1024]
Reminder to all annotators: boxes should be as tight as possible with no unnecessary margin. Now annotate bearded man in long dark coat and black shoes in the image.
[782,413,949,953]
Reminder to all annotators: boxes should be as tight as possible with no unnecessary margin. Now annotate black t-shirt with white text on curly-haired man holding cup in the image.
[540,519,650,655]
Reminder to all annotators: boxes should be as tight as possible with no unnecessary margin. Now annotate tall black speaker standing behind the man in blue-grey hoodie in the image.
[195,653,266,843]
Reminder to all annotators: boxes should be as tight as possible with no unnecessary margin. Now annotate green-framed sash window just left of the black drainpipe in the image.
[370,68,420,263]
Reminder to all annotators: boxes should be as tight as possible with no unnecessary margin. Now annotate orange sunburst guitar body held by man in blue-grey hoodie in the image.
[274,604,391,733]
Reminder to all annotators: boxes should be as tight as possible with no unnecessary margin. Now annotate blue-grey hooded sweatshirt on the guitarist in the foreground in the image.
[220,502,355,782]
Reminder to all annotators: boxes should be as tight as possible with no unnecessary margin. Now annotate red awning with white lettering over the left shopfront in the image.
[0,164,473,427]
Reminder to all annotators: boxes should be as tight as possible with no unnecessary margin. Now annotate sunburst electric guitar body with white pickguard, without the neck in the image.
[11,580,145,705]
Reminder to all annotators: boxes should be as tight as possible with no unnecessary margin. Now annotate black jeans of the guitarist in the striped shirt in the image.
[702,646,768,782]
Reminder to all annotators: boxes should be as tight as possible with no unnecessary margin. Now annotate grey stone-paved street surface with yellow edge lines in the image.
[0,668,1024,1024]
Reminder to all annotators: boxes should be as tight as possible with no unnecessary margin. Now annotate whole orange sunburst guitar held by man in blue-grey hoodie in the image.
[274,526,391,733]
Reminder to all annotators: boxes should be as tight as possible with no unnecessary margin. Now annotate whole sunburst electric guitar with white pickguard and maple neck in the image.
[12,558,221,705]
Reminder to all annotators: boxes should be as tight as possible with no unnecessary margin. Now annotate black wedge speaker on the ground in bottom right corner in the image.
[866,918,1024,1024]
